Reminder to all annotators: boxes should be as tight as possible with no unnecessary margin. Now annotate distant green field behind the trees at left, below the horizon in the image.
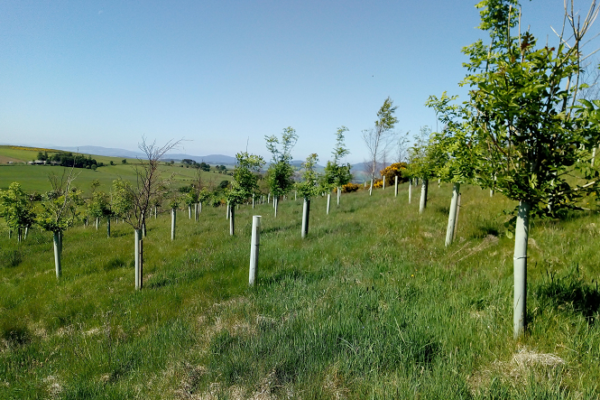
[0,164,232,192]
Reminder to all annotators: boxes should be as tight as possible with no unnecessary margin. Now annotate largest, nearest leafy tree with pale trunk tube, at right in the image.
[436,0,599,337]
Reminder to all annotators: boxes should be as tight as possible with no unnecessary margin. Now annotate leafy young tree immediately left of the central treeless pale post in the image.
[227,151,265,236]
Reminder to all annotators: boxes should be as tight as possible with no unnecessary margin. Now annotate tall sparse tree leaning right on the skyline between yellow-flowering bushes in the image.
[362,97,398,189]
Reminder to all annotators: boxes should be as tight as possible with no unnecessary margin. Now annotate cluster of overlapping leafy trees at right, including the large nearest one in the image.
[409,0,600,337]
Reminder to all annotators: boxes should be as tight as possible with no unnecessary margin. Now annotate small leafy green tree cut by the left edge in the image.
[0,182,36,242]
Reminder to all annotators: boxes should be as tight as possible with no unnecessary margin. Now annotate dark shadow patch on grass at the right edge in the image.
[536,265,600,323]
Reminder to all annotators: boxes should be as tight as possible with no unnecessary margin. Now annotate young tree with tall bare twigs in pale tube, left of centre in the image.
[113,138,179,290]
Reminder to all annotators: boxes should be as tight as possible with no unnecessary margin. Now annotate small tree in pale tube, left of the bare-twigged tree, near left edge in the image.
[37,168,81,278]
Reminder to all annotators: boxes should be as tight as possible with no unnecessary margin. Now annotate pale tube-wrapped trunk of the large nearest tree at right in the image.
[513,202,531,338]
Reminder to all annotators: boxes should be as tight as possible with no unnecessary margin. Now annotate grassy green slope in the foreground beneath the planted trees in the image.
[0,185,600,399]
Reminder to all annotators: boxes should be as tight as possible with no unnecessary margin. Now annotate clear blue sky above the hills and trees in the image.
[0,0,598,163]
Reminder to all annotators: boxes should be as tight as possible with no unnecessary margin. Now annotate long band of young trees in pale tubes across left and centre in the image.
[0,121,360,289]
